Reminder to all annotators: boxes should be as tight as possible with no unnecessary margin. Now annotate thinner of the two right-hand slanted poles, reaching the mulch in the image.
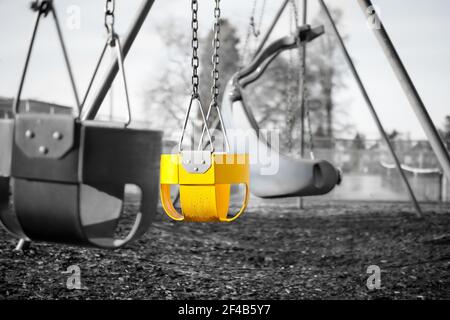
[319,0,422,217]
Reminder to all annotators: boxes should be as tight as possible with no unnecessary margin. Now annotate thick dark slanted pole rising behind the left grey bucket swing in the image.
[81,0,155,120]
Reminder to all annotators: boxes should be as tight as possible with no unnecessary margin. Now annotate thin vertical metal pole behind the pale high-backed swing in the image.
[298,0,312,209]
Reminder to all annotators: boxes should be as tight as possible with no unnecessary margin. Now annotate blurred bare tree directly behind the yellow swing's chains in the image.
[146,19,239,143]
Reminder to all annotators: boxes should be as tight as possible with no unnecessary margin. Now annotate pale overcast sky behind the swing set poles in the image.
[0,0,450,138]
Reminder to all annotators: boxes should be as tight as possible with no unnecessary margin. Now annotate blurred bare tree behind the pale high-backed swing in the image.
[241,6,352,152]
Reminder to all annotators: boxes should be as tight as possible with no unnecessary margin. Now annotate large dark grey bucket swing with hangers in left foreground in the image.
[0,0,162,248]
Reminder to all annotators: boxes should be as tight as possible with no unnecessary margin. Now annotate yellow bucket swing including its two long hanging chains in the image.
[160,0,250,222]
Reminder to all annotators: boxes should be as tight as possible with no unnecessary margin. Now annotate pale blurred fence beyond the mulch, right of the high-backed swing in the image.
[314,139,450,201]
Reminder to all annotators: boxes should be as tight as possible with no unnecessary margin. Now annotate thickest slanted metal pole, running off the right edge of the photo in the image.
[358,0,450,179]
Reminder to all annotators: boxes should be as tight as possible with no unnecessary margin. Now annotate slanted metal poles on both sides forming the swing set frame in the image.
[43,0,450,216]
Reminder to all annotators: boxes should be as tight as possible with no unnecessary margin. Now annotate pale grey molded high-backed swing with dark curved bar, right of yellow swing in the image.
[222,2,341,198]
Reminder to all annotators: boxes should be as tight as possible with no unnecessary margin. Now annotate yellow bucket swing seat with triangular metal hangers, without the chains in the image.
[160,97,250,222]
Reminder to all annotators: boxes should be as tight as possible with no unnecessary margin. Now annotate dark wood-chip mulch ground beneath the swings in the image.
[0,201,450,299]
